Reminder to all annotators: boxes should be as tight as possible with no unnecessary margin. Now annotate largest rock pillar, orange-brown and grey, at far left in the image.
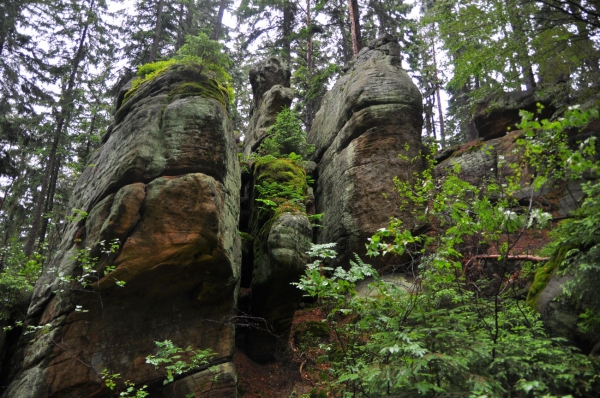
[3,67,241,398]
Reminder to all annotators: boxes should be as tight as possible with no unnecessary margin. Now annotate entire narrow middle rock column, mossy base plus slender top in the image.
[239,57,312,362]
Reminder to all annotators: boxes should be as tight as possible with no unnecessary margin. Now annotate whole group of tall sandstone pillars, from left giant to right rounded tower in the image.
[3,36,434,398]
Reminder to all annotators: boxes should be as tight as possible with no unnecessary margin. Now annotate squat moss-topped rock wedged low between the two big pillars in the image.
[240,158,312,363]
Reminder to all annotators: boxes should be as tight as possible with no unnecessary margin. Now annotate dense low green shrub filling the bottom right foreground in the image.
[297,244,600,397]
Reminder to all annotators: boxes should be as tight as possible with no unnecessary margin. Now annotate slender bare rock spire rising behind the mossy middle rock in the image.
[244,57,294,155]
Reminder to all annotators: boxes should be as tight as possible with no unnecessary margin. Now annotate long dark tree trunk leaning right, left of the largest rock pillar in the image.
[25,0,92,257]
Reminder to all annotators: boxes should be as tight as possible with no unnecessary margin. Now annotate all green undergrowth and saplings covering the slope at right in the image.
[297,105,600,397]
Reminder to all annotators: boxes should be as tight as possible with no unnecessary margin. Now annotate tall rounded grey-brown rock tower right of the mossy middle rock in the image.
[308,36,422,265]
